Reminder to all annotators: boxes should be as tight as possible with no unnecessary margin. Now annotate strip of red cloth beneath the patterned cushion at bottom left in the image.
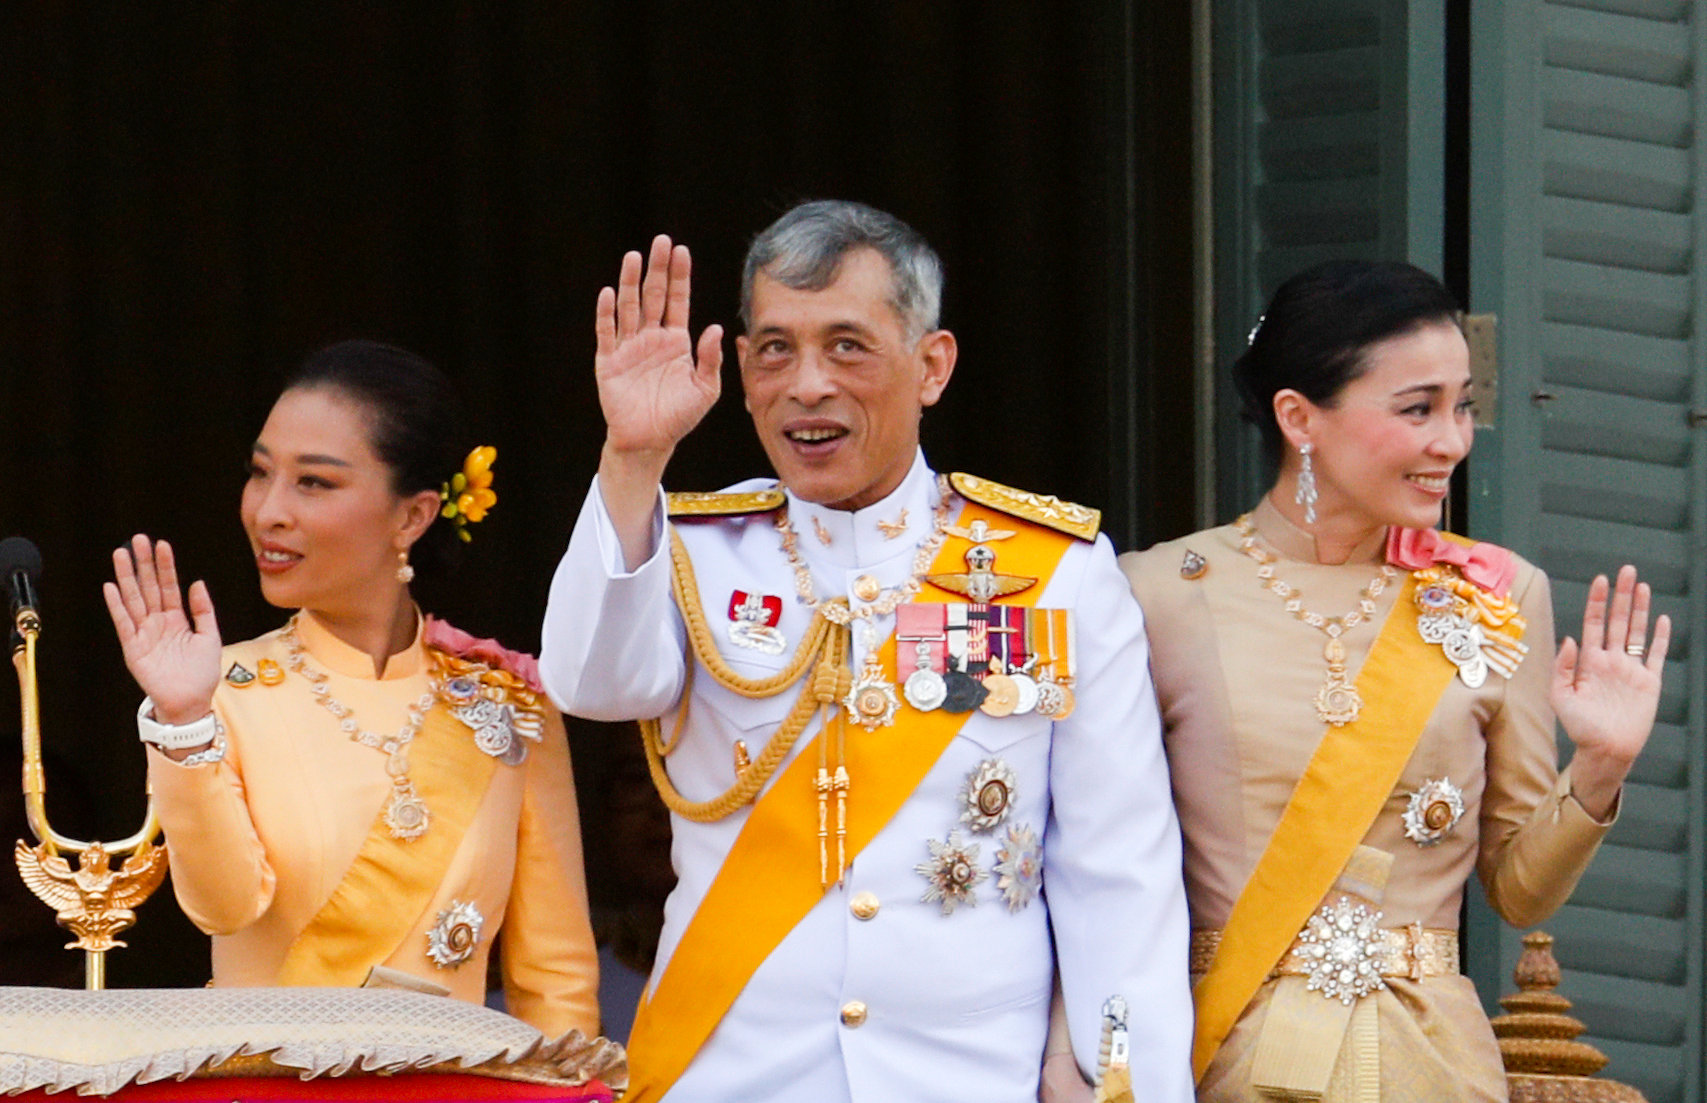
[7,1072,611,1103]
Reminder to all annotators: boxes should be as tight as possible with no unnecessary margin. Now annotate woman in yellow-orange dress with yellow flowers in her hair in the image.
[104,341,599,1036]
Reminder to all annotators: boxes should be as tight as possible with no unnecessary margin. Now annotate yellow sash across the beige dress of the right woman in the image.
[1191,575,1458,1079]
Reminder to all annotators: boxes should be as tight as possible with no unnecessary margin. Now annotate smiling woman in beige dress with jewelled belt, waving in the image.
[1121,261,1669,1101]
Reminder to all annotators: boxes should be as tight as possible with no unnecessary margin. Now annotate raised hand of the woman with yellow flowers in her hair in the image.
[101,533,220,724]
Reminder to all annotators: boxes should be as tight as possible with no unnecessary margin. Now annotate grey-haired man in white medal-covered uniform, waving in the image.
[541,203,1191,1103]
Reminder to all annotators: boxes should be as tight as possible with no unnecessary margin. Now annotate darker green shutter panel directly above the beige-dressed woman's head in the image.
[1210,0,1444,519]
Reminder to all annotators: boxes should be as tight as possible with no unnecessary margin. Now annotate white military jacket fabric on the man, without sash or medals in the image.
[541,454,1191,1103]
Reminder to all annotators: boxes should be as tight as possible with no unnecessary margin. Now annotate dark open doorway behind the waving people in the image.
[0,0,1195,987]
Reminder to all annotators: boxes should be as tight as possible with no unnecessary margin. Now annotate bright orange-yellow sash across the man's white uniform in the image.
[625,502,1075,1103]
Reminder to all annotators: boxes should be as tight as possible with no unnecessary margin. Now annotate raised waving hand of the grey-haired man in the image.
[594,234,724,456]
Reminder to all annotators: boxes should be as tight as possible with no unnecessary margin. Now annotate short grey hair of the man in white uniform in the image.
[741,200,942,341]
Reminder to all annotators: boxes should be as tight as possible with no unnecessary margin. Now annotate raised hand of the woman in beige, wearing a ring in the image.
[1552,565,1671,820]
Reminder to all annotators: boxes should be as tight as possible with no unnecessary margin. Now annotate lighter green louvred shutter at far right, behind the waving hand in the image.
[1468,0,1707,1103]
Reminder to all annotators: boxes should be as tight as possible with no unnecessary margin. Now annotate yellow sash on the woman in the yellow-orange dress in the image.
[277,703,498,987]
